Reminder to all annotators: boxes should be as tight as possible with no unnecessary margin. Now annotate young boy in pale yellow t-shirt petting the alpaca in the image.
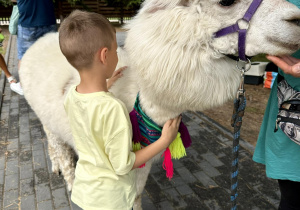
[59,10,181,210]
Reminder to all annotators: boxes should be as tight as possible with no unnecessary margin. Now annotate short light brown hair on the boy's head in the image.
[59,10,116,70]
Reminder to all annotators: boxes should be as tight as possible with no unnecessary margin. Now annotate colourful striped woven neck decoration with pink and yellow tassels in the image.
[129,94,192,179]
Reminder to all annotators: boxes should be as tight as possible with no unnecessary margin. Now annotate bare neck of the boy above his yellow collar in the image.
[76,68,108,94]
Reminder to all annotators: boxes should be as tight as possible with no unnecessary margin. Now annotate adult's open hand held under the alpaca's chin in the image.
[267,55,300,77]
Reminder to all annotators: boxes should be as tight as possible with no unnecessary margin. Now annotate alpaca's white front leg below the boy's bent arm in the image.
[133,160,153,210]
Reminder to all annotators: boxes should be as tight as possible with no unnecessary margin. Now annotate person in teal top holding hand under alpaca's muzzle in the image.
[253,0,300,210]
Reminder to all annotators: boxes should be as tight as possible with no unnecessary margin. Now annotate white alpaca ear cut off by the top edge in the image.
[142,0,190,13]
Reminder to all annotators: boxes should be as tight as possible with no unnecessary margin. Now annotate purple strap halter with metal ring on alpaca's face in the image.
[215,0,263,62]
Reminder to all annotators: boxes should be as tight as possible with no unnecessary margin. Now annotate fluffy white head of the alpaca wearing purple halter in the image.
[125,0,300,118]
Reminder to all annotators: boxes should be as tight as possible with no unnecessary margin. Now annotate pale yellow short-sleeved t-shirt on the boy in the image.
[64,87,136,210]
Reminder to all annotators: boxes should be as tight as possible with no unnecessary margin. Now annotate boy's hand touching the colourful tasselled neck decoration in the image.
[161,116,181,147]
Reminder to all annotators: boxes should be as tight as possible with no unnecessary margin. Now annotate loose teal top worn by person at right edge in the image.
[253,0,300,182]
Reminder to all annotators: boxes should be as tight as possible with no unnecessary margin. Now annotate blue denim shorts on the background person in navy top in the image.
[17,25,57,60]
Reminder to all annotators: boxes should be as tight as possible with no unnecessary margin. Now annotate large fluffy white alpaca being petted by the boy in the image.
[20,0,300,208]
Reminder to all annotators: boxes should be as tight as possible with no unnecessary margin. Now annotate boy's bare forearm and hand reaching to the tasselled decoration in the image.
[132,116,181,169]
